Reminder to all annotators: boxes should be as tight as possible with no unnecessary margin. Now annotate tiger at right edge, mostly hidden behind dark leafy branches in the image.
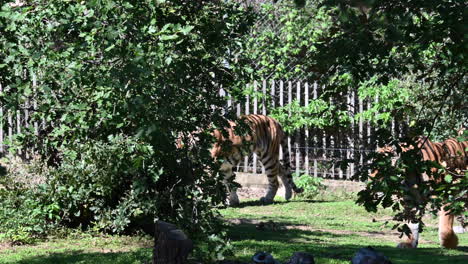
[397,138,468,248]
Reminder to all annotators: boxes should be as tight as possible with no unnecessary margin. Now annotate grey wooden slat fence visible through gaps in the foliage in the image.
[0,76,402,179]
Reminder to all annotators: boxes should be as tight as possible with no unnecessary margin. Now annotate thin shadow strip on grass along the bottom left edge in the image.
[6,249,151,264]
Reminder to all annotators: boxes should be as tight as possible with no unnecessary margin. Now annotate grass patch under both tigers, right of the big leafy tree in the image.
[222,197,468,264]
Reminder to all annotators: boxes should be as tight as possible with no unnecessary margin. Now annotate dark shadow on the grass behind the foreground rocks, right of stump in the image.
[228,223,468,264]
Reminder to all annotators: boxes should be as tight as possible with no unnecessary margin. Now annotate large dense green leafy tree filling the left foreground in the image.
[0,0,252,258]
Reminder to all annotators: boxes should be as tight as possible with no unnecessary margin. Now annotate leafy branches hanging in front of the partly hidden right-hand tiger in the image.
[266,0,468,229]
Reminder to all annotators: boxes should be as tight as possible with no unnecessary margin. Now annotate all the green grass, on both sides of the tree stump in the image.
[0,193,468,264]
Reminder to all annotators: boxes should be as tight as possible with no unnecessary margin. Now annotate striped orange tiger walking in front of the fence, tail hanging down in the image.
[211,115,303,205]
